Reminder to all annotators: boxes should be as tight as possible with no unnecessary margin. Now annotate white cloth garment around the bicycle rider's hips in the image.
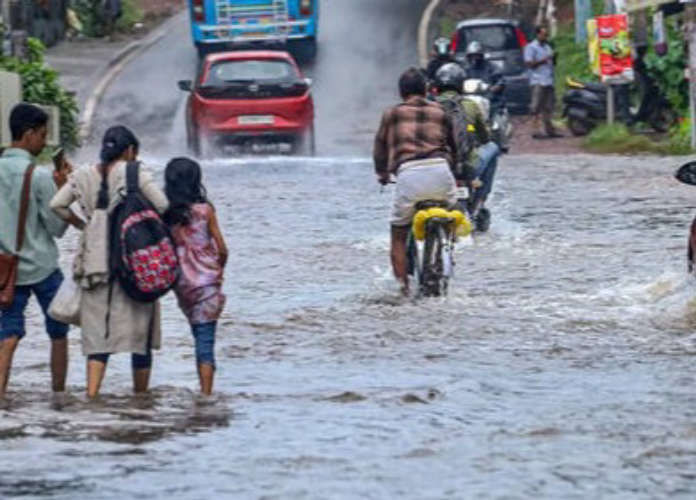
[389,158,457,226]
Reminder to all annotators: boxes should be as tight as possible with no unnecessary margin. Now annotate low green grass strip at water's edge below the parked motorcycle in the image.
[583,120,692,155]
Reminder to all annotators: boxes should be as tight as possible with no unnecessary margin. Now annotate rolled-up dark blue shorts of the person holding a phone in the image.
[0,269,70,341]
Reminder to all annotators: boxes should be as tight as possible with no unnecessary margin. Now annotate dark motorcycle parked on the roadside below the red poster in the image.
[563,77,676,136]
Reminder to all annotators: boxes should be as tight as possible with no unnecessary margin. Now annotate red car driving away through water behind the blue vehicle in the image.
[179,50,314,157]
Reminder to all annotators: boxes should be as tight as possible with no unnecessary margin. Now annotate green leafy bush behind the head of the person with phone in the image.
[0,38,79,149]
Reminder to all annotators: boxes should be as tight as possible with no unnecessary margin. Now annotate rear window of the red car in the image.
[203,60,298,87]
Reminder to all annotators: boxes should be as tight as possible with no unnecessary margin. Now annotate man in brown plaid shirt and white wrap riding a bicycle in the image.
[374,68,468,294]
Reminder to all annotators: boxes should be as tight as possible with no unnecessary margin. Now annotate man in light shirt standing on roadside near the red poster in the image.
[524,26,562,139]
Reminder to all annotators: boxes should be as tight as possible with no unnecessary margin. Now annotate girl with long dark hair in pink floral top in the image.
[164,158,227,395]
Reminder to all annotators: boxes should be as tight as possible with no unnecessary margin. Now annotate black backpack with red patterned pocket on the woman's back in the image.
[109,162,181,302]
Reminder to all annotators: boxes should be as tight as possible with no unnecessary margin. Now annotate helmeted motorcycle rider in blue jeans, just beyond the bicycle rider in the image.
[435,64,500,229]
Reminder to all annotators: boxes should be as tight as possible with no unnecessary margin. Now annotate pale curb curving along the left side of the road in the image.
[78,12,183,142]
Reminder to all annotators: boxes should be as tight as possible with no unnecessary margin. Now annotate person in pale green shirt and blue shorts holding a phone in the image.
[0,104,73,400]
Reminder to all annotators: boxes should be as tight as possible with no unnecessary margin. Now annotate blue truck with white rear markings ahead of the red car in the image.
[188,0,319,62]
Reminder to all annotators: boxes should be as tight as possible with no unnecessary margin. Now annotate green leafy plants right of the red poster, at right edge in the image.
[645,29,689,116]
